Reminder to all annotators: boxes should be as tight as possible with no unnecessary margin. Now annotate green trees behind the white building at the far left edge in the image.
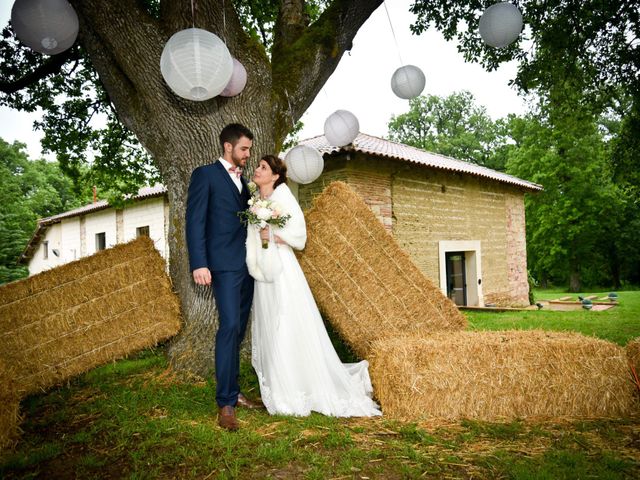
[0,139,81,283]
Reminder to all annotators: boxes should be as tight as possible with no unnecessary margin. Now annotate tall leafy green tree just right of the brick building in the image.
[507,81,624,292]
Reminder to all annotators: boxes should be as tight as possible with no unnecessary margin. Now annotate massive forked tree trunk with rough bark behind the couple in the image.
[71,0,382,376]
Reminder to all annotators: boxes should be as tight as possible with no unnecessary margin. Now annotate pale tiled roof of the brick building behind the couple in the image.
[300,133,542,191]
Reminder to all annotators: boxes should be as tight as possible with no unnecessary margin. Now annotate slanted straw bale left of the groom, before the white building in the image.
[0,237,180,394]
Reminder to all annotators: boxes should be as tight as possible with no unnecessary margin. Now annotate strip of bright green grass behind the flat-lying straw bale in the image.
[465,290,640,345]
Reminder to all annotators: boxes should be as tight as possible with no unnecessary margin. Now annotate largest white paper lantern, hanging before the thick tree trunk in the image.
[160,28,233,101]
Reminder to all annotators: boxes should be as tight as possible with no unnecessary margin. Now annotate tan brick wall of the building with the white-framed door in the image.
[299,155,529,306]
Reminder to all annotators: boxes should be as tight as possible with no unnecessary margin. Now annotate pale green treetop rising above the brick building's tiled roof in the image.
[388,91,504,170]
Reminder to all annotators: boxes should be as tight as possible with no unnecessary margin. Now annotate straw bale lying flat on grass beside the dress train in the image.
[369,330,637,420]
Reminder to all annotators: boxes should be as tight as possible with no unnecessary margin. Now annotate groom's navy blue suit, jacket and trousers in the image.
[186,161,253,407]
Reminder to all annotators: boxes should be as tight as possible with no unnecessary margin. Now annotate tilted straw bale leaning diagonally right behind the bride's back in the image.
[298,182,466,358]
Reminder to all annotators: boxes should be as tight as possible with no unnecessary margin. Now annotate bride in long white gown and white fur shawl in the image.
[247,155,381,417]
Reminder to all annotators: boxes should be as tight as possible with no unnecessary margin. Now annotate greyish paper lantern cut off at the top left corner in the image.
[11,0,78,55]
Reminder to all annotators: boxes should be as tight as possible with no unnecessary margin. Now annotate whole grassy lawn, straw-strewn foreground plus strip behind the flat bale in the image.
[0,286,640,479]
